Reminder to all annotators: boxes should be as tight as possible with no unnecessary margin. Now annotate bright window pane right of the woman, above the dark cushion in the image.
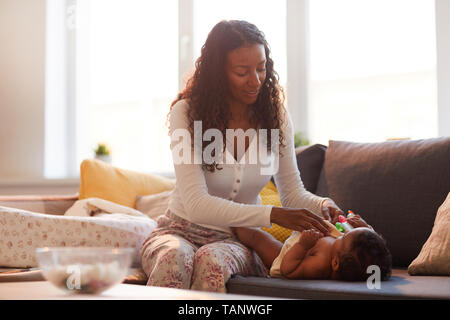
[309,0,438,144]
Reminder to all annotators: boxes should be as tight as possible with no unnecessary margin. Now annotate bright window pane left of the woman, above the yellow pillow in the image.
[76,0,178,173]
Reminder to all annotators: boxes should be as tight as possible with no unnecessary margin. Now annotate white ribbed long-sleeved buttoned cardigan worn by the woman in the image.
[168,100,326,232]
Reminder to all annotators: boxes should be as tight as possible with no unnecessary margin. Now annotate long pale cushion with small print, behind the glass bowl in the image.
[0,207,156,268]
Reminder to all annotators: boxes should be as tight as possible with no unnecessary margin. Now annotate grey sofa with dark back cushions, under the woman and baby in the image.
[0,137,450,299]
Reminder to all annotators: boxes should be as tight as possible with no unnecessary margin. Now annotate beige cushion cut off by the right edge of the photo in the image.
[408,193,450,276]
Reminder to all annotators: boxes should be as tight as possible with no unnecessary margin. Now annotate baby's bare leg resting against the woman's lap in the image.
[232,227,283,269]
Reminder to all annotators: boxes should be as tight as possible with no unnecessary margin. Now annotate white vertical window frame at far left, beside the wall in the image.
[43,0,77,178]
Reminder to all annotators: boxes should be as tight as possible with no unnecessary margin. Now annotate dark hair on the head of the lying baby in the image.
[337,230,392,281]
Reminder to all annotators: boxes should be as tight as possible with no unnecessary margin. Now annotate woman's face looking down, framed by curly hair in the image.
[226,44,266,105]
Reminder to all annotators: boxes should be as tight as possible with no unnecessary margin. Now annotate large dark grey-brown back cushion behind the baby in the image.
[317,137,450,267]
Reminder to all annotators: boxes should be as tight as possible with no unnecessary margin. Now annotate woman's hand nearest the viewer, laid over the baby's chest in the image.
[270,207,331,235]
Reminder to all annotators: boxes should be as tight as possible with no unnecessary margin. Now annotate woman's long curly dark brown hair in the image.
[168,20,285,172]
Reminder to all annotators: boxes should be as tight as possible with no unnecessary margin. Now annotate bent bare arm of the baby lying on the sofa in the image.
[280,230,329,279]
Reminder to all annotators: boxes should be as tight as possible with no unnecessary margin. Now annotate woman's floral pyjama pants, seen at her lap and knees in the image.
[140,210,268,292]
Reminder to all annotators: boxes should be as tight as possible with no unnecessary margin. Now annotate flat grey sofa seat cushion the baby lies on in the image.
[227,269,450,299]
